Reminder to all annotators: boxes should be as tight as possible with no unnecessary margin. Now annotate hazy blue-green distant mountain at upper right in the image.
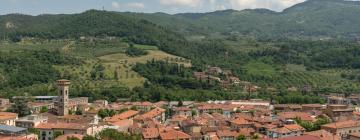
[127,0,360,38]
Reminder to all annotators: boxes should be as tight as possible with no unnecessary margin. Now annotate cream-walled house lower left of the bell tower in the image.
[15,115,48,128]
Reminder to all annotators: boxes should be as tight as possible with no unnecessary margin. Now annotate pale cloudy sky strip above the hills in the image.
[0,0,305,15]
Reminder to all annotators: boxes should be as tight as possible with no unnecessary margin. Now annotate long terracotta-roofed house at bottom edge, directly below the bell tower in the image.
[35,123,93,140]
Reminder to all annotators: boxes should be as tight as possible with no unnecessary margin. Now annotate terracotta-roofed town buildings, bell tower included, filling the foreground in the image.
[0,80,360,140]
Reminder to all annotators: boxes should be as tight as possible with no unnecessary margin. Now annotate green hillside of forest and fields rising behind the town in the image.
[0,0,360,103]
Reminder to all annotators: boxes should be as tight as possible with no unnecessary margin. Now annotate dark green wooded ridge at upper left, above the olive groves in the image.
[0,10,181,46]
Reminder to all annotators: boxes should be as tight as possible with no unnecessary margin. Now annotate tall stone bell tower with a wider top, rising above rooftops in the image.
[57,79,70,116]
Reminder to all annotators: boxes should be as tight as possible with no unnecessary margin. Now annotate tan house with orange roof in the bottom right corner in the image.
[321,120,360,138]
